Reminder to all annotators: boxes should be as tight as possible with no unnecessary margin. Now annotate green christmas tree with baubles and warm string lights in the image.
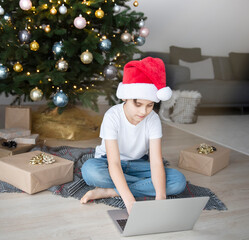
[0,0,149,110]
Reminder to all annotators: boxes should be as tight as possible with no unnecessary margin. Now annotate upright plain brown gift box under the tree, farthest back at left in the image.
[5,106,31,130]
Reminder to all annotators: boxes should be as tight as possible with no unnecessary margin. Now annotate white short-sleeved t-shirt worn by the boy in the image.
[95,103,162,160]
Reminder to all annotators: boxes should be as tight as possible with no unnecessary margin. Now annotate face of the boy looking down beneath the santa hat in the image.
[124,99,154,125]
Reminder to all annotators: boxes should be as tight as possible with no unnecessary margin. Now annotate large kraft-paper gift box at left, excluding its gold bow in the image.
[0,151,74,194]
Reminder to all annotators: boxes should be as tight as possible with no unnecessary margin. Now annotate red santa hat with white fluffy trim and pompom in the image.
[116,57,172,102]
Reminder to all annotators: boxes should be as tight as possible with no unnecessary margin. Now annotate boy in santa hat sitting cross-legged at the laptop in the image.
[81,57,186,213]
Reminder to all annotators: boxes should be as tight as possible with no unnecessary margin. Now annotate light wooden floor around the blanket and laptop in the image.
[0,125,249,240]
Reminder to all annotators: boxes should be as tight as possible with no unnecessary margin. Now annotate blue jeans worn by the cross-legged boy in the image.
[81,157,186,197]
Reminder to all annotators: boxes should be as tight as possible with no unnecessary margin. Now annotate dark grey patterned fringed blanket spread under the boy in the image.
[0,146,227,210]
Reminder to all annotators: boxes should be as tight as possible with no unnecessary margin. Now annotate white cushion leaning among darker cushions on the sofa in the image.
[179,58,214,80]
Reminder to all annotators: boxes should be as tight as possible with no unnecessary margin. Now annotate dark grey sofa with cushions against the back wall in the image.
[143,46,249,110]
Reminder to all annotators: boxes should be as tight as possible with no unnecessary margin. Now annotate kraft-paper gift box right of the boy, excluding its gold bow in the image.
[178,145,230,176]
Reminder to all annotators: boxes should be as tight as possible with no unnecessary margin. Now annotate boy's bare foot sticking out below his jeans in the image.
[80,188,119,204]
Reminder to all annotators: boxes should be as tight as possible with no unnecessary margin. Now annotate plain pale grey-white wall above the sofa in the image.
[129,0,249,56]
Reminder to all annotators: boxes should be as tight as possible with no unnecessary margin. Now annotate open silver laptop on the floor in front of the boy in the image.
[108,197,209,236]
